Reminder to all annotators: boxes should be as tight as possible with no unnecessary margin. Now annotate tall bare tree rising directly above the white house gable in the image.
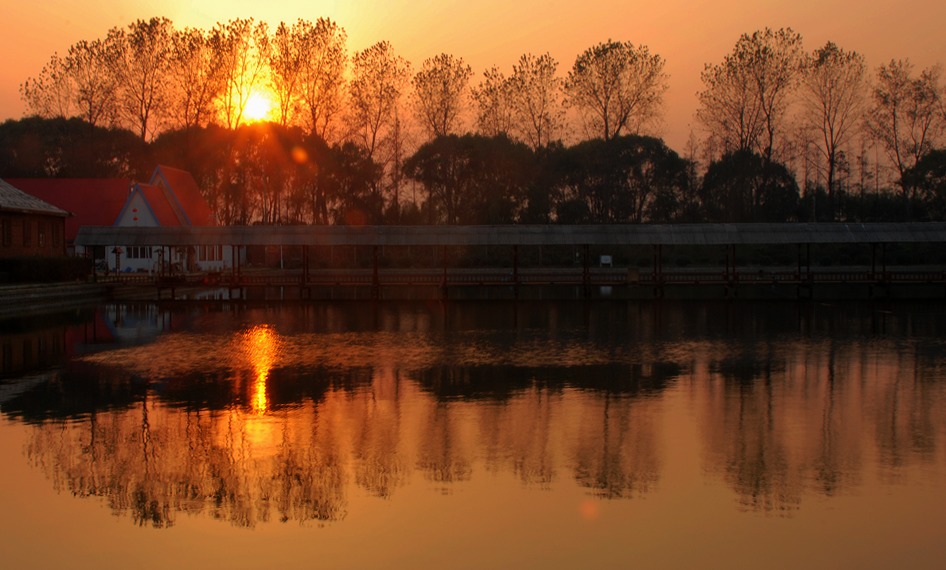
[108,18,173,140]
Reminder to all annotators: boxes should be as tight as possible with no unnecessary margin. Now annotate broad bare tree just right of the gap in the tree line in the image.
[697,28,803,160]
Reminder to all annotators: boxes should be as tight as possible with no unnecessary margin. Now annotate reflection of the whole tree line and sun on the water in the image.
[2,304,946,527]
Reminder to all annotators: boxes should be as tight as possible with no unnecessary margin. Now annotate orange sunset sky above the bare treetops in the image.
[0,0,946,150]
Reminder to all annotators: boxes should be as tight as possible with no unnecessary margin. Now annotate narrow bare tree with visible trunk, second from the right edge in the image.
[802,42,867,212]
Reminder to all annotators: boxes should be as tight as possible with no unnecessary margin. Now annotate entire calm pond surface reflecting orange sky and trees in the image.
[0,302,946,568]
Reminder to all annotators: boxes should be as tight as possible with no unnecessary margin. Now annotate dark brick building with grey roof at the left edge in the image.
[0,180,69,258]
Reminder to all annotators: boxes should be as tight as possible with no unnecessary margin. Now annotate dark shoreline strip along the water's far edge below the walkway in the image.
[0,270,946,319]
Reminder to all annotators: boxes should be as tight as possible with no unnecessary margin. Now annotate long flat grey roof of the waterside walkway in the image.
[76,222,946,246]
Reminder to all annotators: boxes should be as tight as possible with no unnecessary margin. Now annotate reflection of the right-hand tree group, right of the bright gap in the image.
[692,340,946,512]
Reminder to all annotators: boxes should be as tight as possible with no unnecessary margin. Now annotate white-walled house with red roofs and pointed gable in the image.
[9,165,232,272]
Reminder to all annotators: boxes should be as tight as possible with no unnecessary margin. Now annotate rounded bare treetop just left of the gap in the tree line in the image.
[565,40,667,140]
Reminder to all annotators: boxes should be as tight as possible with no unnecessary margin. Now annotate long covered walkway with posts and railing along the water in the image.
[76,223,946,298]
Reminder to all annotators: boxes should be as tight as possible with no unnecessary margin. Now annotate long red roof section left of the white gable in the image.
[5,178,132,241]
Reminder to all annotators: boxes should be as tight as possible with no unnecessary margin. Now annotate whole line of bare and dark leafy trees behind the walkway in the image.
[7,18,946,223]
